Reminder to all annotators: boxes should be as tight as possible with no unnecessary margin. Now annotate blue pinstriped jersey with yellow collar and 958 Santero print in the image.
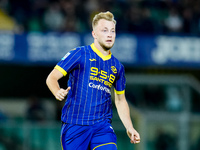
[55,43,126,125]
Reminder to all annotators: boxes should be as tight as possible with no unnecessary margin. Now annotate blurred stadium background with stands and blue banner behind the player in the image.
[0,0,200,150]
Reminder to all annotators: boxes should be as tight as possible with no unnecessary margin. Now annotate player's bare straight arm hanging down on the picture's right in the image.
[115,92,140,144]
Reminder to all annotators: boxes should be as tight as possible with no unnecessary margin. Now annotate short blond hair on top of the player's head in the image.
[92,11,117,29]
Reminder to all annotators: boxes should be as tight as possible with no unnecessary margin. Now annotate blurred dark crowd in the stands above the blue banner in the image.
[0,0,200,36]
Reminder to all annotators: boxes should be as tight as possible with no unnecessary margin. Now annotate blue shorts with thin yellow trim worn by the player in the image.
[61,121,117,150]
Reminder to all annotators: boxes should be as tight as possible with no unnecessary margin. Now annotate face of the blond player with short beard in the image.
[94,19,116,51]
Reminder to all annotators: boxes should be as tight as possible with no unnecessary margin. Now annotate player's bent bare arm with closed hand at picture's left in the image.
[46,69,70,101]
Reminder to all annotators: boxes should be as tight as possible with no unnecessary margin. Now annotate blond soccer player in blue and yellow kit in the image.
[46,11,140,150]
